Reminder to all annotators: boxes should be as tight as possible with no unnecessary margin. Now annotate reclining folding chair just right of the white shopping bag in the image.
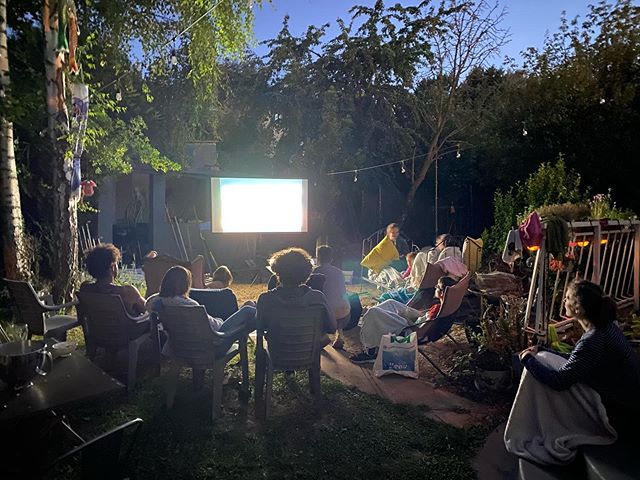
[401,274,471,377]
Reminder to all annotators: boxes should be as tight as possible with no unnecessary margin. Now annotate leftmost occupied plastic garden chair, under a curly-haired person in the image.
[77,292,160,392]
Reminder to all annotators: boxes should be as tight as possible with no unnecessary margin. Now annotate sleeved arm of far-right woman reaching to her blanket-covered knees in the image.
[522,337,613,390]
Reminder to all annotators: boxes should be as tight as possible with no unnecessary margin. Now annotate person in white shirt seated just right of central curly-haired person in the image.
[313,245,351,349]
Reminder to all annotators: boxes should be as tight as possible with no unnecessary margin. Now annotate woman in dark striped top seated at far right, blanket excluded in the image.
[520,280,640,433]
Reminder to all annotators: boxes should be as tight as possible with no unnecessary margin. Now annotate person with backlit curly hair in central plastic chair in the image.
[258,248,336,338]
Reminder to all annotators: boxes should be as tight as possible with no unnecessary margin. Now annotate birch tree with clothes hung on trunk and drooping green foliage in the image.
[11,0,261,298]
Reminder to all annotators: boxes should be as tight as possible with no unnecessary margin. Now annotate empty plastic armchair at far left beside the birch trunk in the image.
[4,278,78,341]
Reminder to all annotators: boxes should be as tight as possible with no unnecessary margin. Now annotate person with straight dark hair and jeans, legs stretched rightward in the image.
[146,266,256,338]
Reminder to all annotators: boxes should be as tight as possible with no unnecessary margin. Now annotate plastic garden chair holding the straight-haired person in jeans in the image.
[159,305,249,420]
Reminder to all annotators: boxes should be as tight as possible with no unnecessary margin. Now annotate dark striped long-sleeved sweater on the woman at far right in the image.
[522,323,640,409]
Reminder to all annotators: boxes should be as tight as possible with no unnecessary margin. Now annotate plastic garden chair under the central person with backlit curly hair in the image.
[256,306,327,417]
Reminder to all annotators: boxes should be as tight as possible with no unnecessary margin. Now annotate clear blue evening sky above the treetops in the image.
[254,0,624,64]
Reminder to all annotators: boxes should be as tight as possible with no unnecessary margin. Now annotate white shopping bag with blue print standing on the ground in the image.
[373,332,418,378]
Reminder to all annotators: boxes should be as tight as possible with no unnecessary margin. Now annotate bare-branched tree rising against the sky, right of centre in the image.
[402,0,506,228]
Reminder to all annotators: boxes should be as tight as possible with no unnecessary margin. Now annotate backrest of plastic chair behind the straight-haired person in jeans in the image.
[159,305,221,365]
